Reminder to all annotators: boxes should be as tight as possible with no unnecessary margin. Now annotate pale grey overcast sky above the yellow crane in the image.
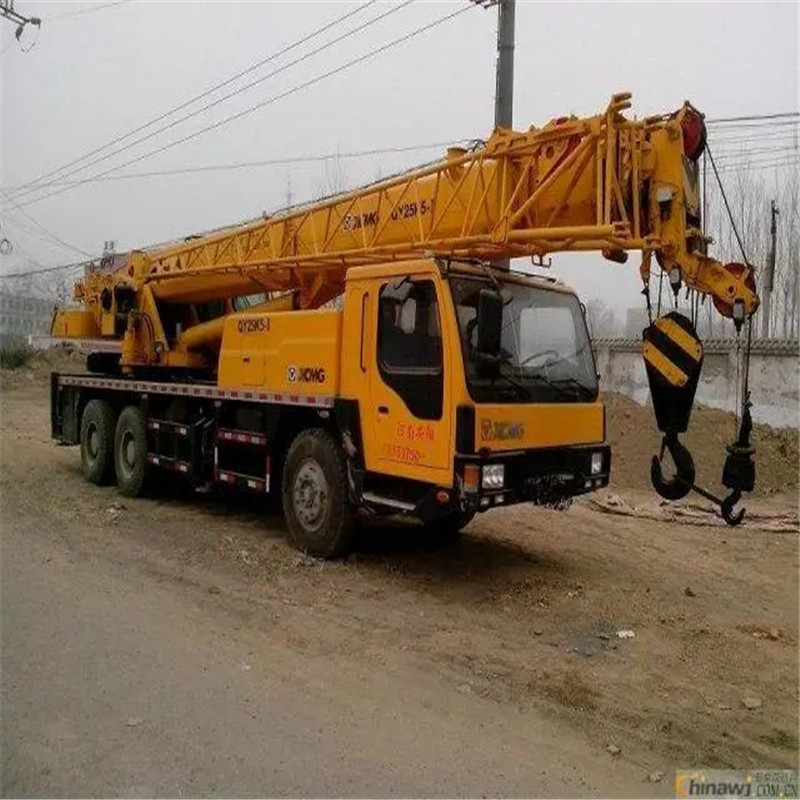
[0,0,800,316]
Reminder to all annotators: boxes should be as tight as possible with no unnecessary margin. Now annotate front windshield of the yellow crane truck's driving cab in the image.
[450,277,598,403]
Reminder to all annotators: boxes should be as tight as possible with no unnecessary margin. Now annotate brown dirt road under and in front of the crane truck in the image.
[0,370,799,796]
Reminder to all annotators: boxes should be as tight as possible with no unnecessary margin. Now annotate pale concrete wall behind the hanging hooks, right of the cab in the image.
[594,339,800,427]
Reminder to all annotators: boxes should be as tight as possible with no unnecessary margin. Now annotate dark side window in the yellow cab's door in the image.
[378,278,444,419]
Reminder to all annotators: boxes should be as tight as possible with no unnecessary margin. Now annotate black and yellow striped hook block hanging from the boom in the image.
[642,311,703,433]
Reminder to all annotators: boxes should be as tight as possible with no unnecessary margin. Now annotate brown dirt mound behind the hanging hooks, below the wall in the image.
[601,393,800,495]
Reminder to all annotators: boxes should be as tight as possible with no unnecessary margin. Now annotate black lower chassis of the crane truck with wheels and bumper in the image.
[51,373,610,558]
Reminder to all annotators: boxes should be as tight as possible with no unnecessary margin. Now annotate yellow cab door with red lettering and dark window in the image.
[365,275,452,485]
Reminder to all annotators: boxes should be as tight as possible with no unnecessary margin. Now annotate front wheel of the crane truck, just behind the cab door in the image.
[282,428,355,558]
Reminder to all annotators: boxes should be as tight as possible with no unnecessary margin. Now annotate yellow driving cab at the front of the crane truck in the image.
[339,259,610,521]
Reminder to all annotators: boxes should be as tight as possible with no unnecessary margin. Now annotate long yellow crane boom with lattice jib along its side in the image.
[59,93,759,344]
